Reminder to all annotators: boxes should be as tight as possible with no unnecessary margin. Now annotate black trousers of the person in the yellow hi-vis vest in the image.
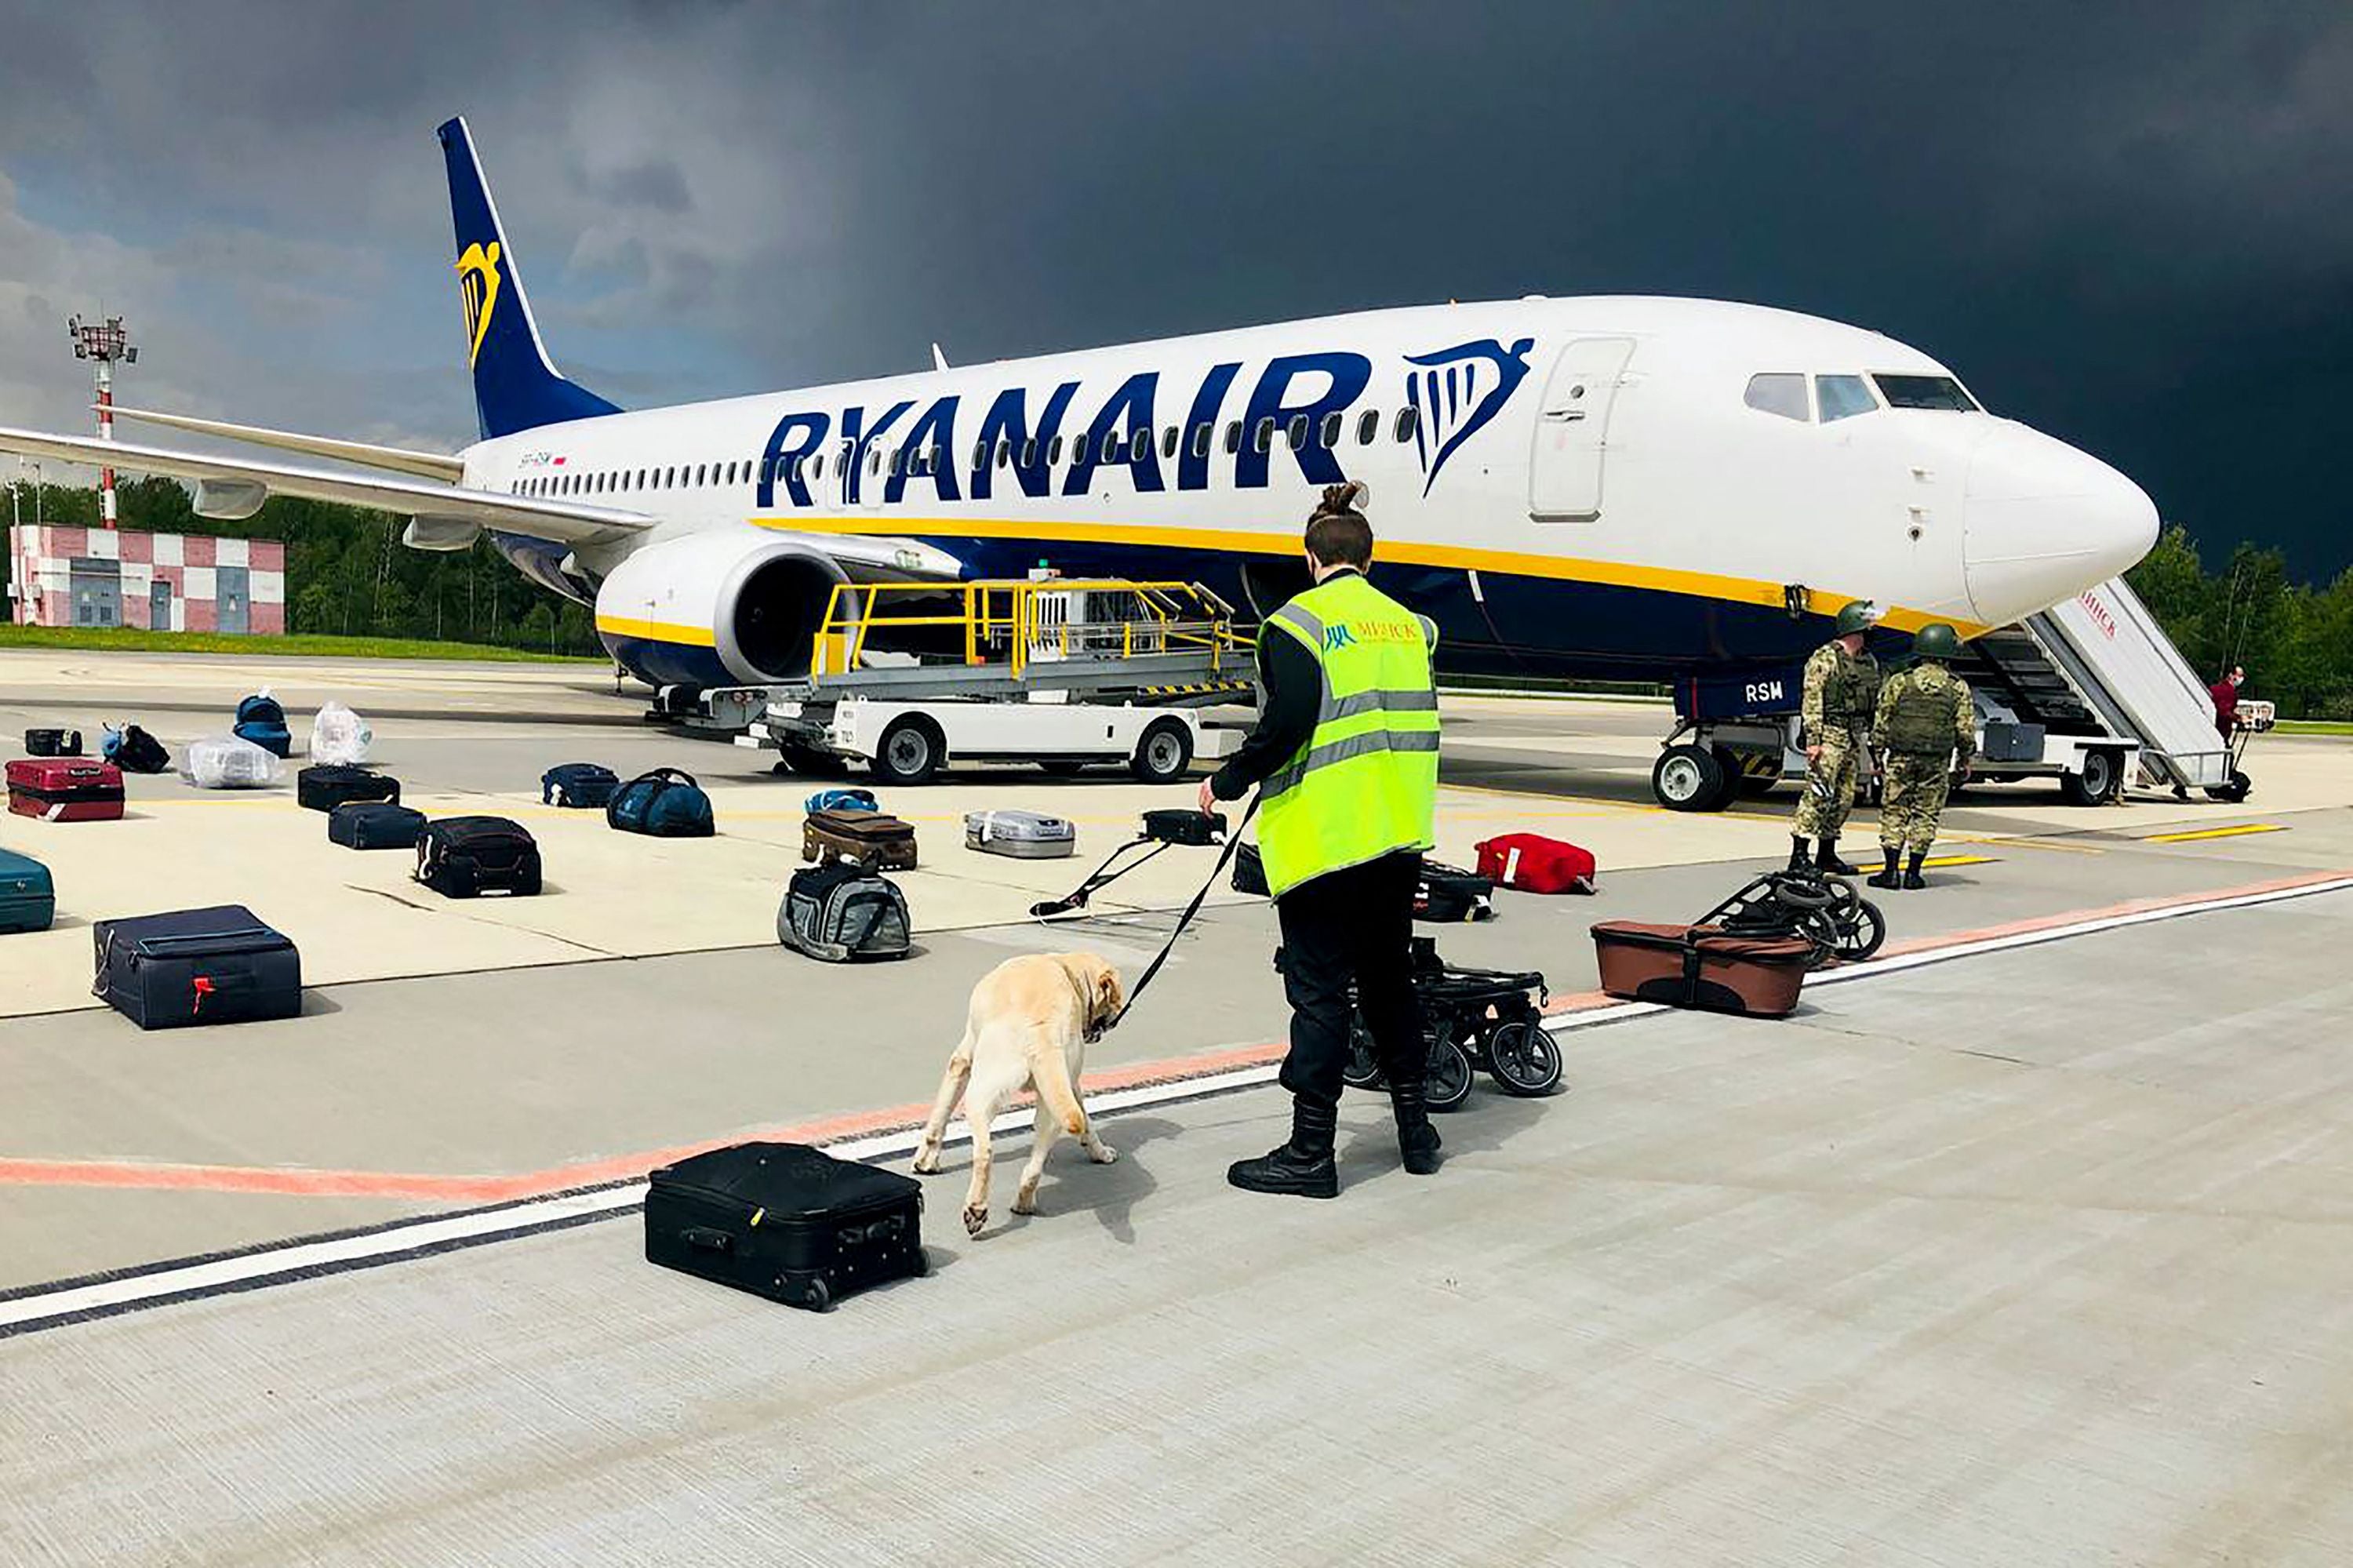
[1275,850,1428,1107]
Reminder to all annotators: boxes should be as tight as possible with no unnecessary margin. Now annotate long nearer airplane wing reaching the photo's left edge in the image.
[0,426,654,548]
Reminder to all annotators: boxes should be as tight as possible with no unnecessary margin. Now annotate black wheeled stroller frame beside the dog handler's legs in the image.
[1275,937,1560,1111]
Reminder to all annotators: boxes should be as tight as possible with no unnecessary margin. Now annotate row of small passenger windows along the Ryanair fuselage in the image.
[508,405,1421,494]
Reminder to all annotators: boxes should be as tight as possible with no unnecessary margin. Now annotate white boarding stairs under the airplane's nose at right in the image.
[1955,577,2231,789]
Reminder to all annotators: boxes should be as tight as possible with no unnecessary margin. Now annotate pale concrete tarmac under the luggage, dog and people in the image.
[0,652,2353,1563]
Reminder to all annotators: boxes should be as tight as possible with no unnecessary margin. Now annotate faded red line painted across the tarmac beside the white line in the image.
[0,869,2353,1203]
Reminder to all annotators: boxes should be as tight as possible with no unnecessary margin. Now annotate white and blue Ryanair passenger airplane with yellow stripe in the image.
[0,120,2158,701]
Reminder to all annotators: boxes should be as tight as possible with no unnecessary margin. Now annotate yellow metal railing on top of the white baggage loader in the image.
[809,577,1249,678]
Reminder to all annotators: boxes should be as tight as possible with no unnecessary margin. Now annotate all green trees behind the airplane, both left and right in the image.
[9,478,2353,718]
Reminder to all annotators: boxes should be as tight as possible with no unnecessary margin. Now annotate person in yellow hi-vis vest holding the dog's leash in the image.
[1200,482,1438,1199]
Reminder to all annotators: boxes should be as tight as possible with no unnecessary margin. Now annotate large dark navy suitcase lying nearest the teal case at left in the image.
[89,904,301,1029]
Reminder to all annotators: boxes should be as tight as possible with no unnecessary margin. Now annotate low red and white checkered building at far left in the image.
[7,525,287,635]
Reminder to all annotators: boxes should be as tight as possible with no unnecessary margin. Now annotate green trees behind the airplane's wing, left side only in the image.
[9,478,602,654]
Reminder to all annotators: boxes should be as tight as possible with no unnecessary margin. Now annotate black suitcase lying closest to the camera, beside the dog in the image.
[645,1144,932,1312]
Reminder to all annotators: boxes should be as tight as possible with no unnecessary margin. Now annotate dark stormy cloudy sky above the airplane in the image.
[0,2,2353,572]
